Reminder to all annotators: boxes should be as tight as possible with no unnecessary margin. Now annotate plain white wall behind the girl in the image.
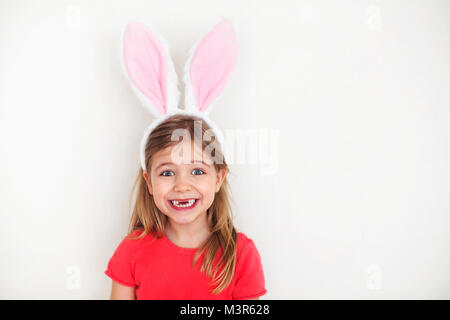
[0,0,450,299]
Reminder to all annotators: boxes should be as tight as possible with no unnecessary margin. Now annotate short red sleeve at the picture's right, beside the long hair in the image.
[232,239,267,300]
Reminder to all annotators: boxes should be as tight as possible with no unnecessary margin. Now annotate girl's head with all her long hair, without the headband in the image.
[129,114,237,293]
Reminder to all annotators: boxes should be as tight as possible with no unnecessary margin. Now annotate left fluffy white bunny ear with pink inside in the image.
[121,21,180,117]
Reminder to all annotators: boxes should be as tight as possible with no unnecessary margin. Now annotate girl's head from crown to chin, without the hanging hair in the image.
[143,115,228,229]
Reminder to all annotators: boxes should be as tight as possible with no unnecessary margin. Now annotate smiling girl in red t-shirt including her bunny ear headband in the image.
[105,21,267,300]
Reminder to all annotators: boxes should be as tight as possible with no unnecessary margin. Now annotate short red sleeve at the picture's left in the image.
[105,238,136,287]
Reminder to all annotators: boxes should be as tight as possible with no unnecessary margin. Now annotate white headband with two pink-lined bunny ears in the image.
[121,20,237,171]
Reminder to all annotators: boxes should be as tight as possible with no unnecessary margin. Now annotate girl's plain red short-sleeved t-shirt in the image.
[105,230,267,300]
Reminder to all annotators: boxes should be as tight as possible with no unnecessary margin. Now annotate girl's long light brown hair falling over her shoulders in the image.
[124,115,237,294]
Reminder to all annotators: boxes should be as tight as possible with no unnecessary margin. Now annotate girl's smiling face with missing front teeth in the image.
[144,141,226,225]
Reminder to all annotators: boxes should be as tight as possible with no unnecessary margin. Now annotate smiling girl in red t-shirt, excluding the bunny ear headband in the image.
[106,115,266,300]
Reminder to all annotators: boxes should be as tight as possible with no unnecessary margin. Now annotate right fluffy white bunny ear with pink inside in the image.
[183,19,237,114]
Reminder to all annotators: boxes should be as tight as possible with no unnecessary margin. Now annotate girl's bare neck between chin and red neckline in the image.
[164,213,212,248]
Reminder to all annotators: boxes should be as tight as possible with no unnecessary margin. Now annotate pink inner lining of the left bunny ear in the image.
[123,22,168,115]
